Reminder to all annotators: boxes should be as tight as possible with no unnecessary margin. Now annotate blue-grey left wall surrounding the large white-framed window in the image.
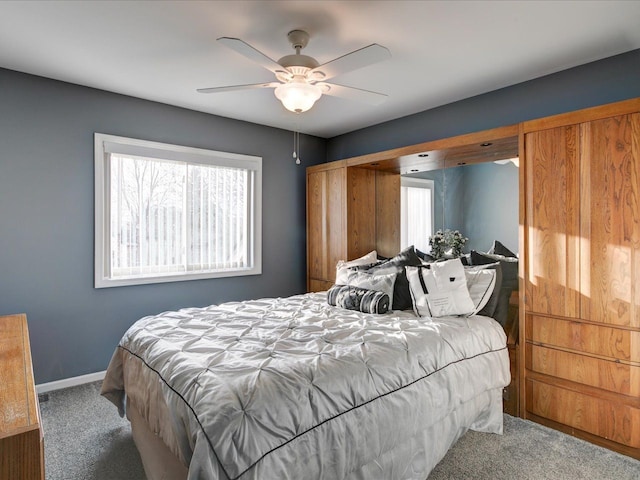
[0,69,326,383]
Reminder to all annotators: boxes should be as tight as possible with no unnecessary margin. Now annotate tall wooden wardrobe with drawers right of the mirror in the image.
[520,99,640,458]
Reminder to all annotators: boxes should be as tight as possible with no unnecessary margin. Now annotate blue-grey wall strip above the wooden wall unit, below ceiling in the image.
[327,49,640,161]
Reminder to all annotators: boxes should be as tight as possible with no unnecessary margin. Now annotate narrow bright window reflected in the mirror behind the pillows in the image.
[400,177,434,252]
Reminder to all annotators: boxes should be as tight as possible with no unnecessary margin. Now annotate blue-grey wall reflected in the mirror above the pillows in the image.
[402,159,519,253]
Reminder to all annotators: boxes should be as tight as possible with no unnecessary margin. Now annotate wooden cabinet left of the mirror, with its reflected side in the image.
[307,160,400,292]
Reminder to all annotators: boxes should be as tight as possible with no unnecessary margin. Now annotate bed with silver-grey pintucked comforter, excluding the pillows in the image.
[102,293,510,480]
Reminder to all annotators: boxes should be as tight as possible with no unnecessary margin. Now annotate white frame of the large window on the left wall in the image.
[94,132,262,288]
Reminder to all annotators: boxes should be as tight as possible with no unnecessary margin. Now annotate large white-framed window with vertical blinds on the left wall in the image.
[95,133,262,288]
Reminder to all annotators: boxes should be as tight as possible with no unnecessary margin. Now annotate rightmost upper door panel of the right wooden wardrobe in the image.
[580,114,640,327]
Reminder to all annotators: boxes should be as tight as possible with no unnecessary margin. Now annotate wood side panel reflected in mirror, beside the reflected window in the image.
[376,171,400,257]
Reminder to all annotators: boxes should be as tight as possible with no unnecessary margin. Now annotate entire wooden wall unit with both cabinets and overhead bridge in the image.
[307,105,640,459]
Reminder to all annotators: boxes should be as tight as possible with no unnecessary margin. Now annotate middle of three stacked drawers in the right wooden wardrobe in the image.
[526,345,640,396]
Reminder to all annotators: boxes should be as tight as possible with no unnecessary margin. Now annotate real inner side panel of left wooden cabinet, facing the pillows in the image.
[343,167,376,260]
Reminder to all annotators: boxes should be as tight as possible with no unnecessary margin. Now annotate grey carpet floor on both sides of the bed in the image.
[40,382,640,480]
